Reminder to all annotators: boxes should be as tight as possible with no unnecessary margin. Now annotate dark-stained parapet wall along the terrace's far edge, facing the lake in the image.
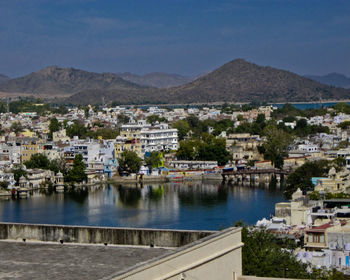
[0,223,215,247]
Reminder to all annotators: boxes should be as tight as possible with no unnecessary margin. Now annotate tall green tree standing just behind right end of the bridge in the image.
[263,125,293,168]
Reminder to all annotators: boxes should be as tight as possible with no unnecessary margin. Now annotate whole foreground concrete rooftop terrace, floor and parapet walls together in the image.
[0,222,243,280]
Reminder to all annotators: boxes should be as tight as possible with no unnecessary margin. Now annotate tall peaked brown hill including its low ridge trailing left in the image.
[67,59,350,104]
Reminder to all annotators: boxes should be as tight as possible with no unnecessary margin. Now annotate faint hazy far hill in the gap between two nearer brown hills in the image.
[117,72,193,88]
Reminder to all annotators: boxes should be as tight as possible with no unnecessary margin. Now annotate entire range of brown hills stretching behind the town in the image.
[0,59,350,104]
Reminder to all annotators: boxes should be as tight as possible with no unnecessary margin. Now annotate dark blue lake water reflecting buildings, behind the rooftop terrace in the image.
[0,182,284,230]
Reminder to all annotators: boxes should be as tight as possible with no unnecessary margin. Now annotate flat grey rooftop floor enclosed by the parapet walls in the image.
[0,241,169,280]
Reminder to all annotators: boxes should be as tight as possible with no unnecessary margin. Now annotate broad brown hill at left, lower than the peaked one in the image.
[0,66,146,96]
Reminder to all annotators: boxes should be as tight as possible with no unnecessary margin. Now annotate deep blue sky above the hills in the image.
[0,0,350,77]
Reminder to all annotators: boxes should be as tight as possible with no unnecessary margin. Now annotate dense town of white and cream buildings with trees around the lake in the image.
[0,100,350,272]
